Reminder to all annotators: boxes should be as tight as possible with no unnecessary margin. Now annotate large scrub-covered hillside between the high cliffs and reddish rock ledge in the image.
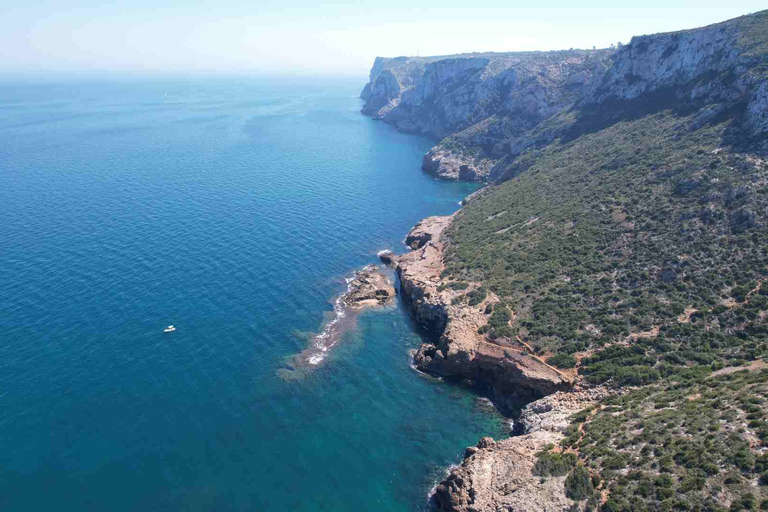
[445,104,768,386]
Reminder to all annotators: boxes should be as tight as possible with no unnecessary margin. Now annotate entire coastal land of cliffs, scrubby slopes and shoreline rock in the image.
[377,11,768,510]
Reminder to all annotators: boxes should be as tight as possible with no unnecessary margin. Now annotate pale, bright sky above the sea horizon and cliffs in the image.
[0,0,766,76]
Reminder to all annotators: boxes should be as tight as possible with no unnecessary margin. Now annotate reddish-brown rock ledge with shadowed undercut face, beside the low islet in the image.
[382,216,573,407]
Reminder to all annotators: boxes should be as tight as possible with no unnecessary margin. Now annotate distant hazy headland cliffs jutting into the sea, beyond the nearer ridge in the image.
[361,50,612,181]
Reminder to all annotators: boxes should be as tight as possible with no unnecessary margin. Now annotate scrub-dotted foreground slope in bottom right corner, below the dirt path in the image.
[535,370,768,511]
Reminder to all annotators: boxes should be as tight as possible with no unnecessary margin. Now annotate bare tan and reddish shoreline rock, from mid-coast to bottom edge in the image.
[380,210,608,512]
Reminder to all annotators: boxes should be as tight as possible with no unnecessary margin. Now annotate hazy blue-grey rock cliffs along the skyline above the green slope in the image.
[361,12,768,181]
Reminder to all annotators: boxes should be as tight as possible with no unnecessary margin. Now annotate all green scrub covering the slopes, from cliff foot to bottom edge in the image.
[436,11,768,512]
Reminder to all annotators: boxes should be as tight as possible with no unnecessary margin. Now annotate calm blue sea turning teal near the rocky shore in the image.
[0,78,504,511]
